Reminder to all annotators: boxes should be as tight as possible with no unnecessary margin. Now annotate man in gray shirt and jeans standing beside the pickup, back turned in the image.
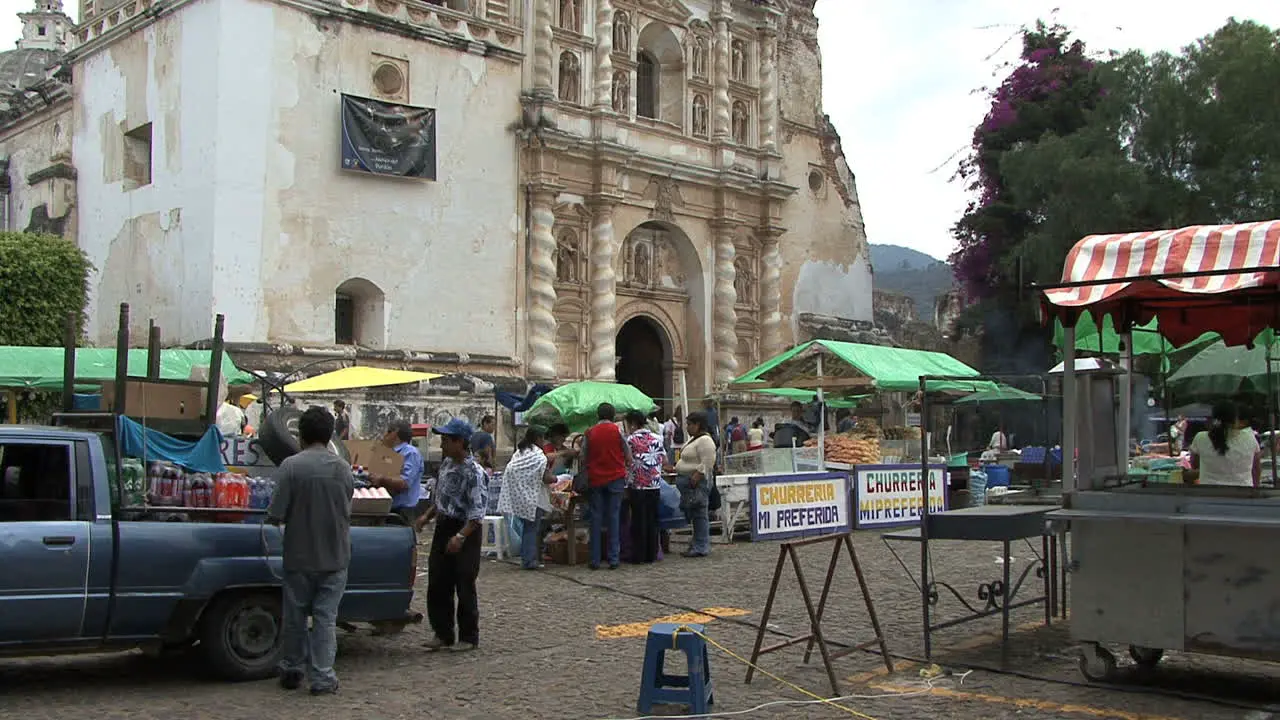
[266,407,356,694]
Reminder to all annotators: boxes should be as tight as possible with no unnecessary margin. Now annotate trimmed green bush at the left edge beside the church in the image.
[0,232,93,347]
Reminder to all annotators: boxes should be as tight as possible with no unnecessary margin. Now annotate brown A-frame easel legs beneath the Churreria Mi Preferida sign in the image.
[746,533,893,696]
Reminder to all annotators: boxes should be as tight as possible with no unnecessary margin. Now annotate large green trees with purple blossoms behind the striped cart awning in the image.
[951,19,1280,366]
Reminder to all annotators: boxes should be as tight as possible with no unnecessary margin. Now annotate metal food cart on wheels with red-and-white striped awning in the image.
[1041,220,1280,680]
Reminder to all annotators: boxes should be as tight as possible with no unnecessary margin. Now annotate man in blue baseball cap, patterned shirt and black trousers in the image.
[426,418,485,651]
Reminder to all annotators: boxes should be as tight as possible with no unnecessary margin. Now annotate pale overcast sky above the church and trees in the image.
[0,0,1280,258]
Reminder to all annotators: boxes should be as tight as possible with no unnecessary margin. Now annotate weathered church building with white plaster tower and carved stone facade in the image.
[0,0,872,397]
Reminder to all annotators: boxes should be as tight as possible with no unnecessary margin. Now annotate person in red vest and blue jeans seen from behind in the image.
[582,402,631,570]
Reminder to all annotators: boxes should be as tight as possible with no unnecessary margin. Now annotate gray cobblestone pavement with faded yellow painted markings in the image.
[0,533,1280,720]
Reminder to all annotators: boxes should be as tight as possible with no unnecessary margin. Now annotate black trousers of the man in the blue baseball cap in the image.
[426,515,484,644]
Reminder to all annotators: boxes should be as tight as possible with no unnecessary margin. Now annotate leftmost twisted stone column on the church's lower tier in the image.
[529,191,557,379]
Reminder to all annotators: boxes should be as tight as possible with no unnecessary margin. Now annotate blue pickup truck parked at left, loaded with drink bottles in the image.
[0,425,421,680]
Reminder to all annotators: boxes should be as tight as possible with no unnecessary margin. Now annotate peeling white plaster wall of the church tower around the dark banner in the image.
[76,0,520,356]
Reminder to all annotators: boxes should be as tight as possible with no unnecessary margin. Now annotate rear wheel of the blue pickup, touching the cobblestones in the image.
[200,592,283,682]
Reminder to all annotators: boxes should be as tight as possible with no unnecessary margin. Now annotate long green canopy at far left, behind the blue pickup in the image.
[0,346,253,389]
